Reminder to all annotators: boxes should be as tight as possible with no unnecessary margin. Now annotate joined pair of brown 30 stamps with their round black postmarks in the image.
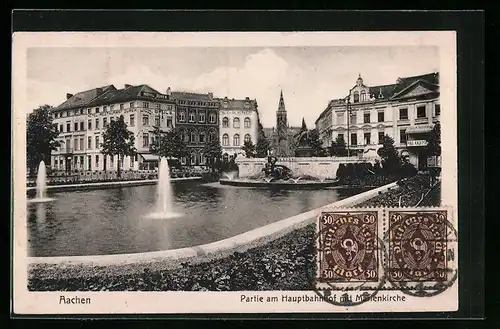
[312,207,458,307]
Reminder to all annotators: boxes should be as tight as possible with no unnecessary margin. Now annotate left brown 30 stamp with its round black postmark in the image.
[311,208,387,307]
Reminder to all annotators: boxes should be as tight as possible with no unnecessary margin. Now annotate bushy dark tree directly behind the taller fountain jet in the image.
[149,127,187,159]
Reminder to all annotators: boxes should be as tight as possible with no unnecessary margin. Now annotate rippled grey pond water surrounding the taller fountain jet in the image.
[27,183,370,257]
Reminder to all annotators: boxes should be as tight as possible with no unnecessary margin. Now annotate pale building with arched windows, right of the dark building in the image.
[219,97,260,157]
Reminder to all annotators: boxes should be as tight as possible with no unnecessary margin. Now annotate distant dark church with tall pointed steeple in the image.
[264,91,302,157]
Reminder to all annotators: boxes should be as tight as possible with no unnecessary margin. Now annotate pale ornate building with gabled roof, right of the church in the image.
[316,73,441,167]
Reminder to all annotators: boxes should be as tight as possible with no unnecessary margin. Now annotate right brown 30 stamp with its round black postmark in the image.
[384,207,458,297]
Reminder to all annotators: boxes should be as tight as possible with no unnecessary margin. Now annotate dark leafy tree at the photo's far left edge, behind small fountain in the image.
[26,105,60,175]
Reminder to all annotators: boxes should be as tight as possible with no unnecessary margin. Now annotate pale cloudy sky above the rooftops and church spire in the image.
[26,46,439,128]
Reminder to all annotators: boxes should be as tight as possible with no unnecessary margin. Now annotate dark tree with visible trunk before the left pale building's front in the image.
[101,115,136,178]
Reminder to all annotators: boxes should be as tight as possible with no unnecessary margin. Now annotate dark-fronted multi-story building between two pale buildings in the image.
[172,91,220,166]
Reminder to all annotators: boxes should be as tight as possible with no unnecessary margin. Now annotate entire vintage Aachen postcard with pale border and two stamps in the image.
[12,31,460,315]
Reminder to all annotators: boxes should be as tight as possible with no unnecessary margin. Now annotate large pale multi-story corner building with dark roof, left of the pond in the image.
[51,85,175,172]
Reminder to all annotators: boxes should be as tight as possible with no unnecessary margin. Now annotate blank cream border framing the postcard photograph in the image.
[12,31,458,314]
